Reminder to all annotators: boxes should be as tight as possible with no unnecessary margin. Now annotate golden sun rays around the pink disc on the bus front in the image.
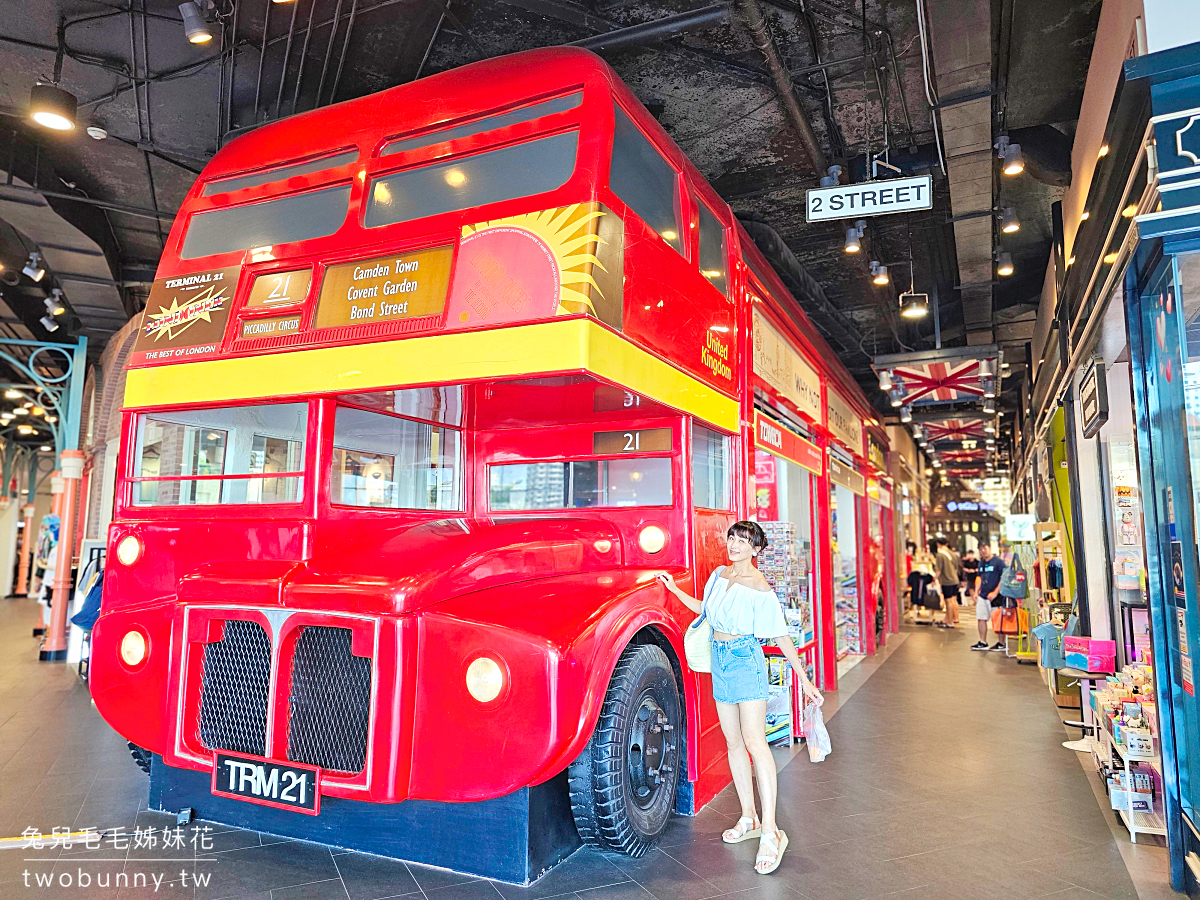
[462,203,608,316]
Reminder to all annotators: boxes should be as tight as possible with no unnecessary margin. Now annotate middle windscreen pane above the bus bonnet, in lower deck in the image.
[329,405,462,510]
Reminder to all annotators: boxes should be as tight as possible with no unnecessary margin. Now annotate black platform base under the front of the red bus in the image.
[150,754,581,884]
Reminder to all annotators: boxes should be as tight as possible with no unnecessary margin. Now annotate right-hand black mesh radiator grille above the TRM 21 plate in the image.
[288,625,371,773]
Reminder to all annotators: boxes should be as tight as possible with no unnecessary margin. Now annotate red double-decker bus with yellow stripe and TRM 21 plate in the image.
[91,49,888,881]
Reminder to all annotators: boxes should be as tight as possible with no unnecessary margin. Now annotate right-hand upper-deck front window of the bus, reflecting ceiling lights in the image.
[366,131,580,234]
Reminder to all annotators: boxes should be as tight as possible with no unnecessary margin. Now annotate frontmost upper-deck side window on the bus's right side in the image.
[608,107,683,253]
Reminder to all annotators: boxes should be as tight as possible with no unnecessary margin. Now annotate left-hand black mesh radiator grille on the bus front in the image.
[200,619,271,756]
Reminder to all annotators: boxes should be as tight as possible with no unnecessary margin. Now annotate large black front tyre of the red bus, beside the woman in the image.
[568,644,683,857]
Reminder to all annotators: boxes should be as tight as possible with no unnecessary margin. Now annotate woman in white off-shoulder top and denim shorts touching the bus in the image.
[659,522,824,875]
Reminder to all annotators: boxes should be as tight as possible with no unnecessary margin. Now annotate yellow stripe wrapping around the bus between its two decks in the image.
[125,318,738,432]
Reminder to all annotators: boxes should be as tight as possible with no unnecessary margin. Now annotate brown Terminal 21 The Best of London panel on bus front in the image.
[130,265,241,366]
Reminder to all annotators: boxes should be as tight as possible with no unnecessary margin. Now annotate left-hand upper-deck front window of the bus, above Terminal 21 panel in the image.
[179,185,350,259]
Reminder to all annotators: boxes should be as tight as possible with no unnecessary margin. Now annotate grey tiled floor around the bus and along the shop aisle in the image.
[0,600,1165,900]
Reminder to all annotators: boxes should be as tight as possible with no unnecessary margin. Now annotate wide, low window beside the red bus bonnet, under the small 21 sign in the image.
[490,457,672,512]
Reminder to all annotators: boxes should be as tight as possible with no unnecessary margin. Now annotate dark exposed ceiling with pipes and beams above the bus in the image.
[0,0,1100,465]
